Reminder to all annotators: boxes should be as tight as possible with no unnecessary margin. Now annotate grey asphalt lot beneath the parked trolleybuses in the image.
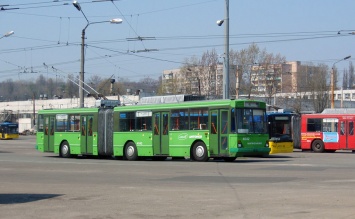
[0,136,355,219]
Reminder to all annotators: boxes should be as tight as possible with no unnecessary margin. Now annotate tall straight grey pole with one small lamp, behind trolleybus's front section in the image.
[217,0,229,99]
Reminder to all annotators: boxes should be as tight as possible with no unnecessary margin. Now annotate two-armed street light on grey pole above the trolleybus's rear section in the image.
[73,1,122,108]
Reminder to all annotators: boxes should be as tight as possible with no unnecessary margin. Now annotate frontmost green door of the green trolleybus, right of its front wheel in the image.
[209,109,229,156]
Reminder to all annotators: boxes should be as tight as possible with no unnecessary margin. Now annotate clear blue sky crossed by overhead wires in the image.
[0,0,355,84]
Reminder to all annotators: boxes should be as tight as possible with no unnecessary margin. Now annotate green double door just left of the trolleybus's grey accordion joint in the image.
[80,116,93,154]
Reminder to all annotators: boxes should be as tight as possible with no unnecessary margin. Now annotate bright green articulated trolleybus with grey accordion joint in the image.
[36,100,270,161]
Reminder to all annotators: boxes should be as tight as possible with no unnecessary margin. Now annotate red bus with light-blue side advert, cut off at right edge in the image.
[301,114,355,152]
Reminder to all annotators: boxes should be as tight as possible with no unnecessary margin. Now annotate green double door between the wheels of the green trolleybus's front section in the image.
[153,112,169,155]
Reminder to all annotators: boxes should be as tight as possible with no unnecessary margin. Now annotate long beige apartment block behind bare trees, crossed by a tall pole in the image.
[162,61,326,99]
